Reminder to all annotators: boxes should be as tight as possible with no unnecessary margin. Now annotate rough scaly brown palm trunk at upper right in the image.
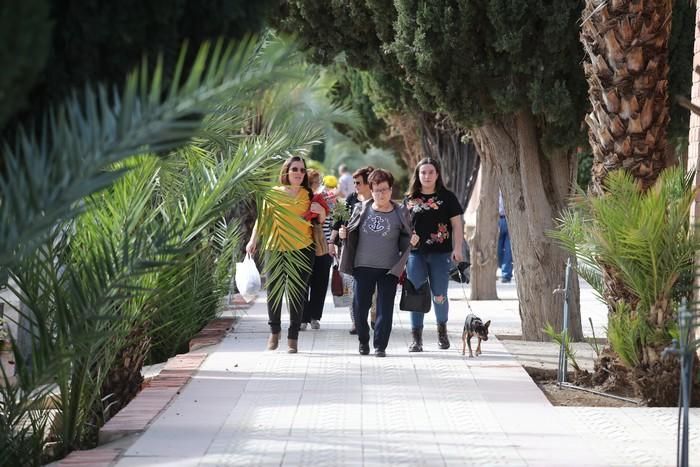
[581,0,673,194]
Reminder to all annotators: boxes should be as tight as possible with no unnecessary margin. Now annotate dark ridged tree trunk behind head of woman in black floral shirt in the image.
[414,113,480,208]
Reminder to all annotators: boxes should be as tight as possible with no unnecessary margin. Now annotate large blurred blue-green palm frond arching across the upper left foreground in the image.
[0,41,296,271]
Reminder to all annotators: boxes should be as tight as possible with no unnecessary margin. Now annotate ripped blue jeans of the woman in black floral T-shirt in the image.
[406,251,452,329]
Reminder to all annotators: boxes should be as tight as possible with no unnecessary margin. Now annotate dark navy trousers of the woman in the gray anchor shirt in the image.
[352,268,399,350]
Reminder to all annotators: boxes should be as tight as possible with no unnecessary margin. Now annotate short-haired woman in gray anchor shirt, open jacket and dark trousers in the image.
[339,169,411,357]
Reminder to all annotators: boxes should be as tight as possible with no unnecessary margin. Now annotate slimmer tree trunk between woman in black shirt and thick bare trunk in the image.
[468,159,498,300]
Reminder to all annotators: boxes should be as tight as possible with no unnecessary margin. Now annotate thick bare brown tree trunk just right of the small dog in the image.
[473,110,583,341]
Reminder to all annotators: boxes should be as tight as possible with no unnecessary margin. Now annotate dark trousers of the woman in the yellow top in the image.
[266,246,315,339]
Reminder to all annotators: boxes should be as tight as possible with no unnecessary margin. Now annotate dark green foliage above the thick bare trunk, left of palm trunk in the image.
[390,0,586,147]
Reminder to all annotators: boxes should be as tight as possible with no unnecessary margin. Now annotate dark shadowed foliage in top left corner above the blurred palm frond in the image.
[0,0,276,136]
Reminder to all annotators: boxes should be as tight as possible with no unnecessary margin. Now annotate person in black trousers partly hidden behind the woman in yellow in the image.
[300,169,336,331]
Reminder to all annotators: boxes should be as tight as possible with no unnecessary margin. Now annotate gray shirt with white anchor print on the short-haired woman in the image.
[354,206,401,269]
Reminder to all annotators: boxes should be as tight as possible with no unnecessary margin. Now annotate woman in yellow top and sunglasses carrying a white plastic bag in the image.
[246,156,326,353]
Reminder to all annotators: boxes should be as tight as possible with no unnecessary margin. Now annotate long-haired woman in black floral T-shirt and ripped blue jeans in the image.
[404,158,464,352]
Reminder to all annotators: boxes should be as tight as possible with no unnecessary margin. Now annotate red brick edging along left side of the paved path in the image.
[58,295,252,467]
